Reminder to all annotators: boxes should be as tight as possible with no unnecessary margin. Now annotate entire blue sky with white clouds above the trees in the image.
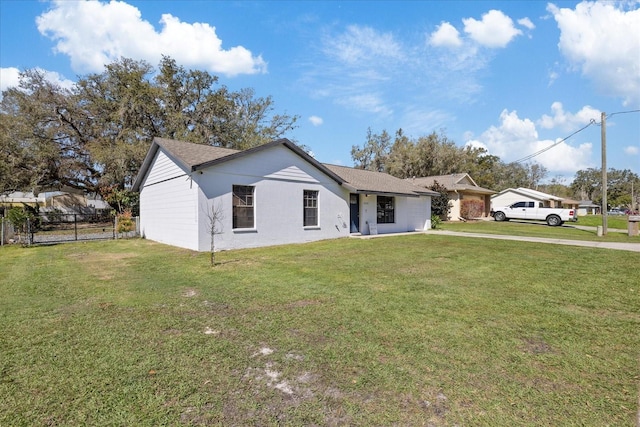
[0,0,640,183]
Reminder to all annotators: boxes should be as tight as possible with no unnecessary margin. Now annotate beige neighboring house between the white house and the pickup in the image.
[409,173,496,221]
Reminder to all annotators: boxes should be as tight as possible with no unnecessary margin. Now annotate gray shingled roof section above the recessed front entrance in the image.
[325,164,437,197]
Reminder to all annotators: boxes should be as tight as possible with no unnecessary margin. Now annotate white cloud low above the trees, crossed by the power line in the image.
[466,110,593,174]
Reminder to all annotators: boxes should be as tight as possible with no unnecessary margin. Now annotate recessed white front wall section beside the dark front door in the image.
[360,195,431,234]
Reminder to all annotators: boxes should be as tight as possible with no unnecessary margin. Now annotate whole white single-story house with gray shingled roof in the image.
[133,138,435,251]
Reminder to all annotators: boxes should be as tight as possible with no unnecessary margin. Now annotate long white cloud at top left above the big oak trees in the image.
[36,0,267,76]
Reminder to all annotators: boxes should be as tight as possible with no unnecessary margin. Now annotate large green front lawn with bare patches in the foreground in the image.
[0,239,640,426]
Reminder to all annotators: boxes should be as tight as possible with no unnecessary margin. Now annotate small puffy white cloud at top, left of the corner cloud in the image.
[462,10,522,48]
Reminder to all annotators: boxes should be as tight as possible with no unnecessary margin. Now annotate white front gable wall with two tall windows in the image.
[194,146,350,251]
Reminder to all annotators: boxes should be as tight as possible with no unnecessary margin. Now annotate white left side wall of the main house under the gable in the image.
[140,149,198,250]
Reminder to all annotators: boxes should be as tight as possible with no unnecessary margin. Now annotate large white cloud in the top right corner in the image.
[547,1,640,105]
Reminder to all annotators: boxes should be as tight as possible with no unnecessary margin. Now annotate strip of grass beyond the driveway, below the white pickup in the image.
[439,216,640,244]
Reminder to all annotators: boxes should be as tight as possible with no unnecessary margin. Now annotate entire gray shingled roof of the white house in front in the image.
[133,138,438,197]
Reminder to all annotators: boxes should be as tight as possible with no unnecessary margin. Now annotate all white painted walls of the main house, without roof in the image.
[140,145,431,251]
